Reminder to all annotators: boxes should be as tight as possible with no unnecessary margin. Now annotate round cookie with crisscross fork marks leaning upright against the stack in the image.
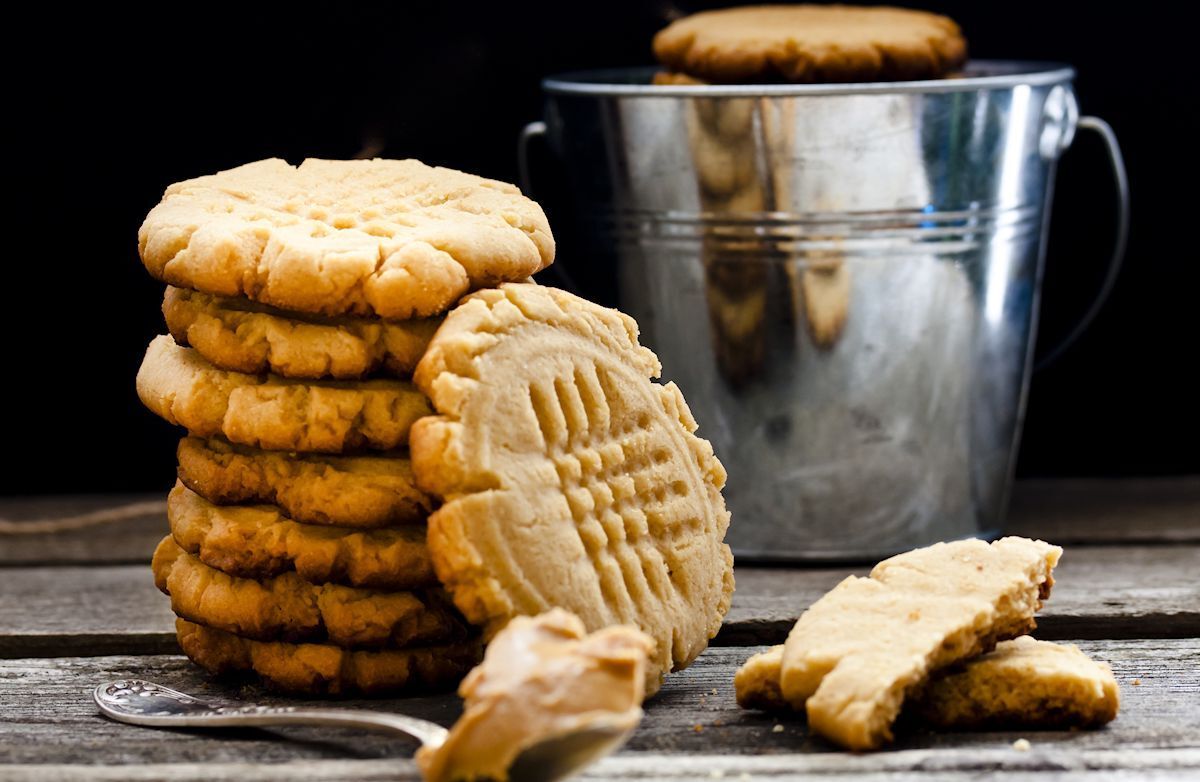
[410,284,733,690]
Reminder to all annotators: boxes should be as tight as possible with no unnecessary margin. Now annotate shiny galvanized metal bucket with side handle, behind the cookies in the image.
[521,62,1126,560]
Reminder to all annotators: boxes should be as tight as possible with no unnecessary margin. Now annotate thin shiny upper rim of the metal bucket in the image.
[541,60,1075,98]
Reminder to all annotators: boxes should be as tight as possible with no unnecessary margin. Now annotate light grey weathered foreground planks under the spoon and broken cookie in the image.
[0,639,1200,780]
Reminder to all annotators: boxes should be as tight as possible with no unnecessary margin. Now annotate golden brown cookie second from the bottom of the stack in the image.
[151,536,466,648]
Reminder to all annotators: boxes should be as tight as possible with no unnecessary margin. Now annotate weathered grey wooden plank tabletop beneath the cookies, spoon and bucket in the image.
[0,479,1200,781]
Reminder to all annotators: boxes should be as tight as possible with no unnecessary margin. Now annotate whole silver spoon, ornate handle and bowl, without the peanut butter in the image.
[92,679,632,782]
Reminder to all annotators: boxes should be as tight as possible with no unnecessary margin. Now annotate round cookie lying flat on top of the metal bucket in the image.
[654,5,967,84]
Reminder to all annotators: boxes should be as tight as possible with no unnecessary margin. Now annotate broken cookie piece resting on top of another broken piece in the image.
[779,537,1062,750]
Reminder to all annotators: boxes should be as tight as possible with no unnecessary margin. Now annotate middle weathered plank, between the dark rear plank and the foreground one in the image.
[0,545,1200,657]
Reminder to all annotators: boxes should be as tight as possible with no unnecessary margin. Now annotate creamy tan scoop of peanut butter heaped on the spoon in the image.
[416,608,654,782]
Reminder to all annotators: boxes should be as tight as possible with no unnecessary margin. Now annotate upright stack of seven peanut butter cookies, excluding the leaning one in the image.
[137,160,554,692]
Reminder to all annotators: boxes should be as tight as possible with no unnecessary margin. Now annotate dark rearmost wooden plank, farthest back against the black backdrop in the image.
[0,476,1200,566]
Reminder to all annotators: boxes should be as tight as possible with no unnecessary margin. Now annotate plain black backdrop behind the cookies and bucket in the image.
[0,0,1200,494]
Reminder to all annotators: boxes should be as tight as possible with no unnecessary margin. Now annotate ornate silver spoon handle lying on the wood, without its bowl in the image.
[94,679,448,747]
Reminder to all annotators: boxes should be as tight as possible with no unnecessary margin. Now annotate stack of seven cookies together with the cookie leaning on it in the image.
[138,155,733,693]
